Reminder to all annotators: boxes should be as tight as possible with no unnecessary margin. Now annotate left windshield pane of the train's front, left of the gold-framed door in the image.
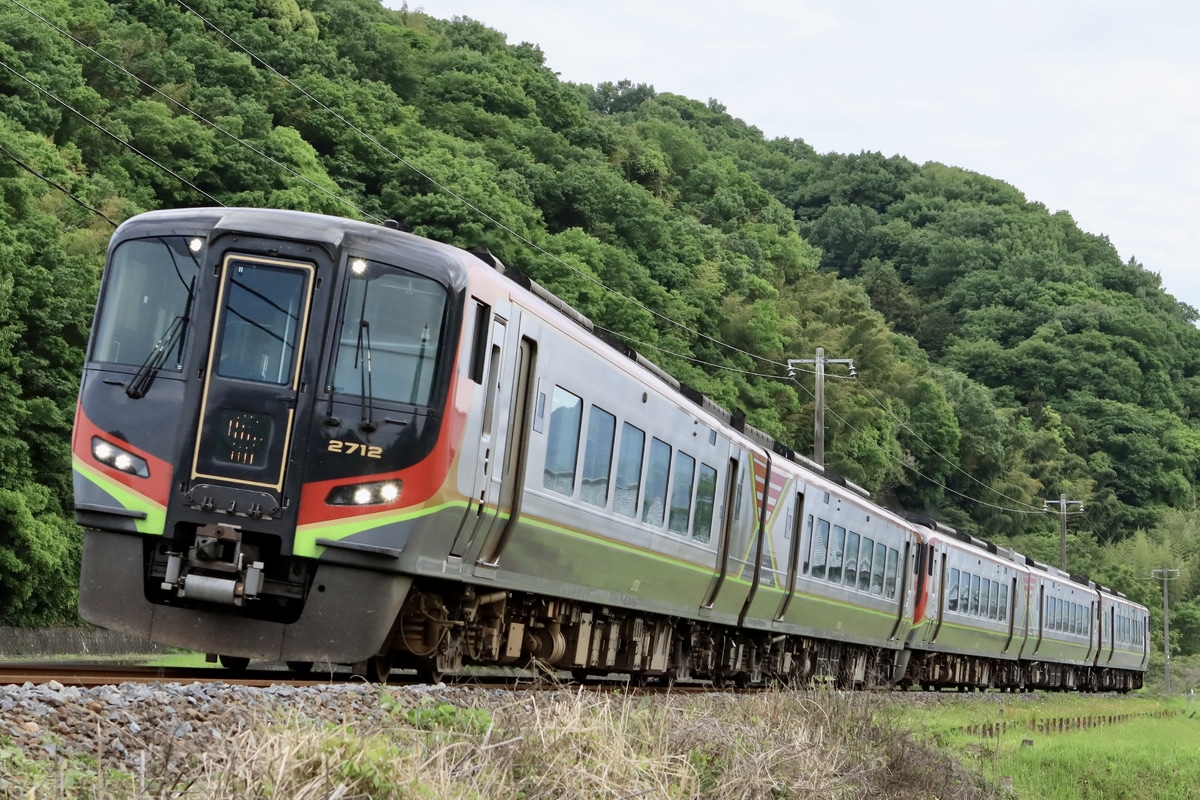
[91,236,199,372]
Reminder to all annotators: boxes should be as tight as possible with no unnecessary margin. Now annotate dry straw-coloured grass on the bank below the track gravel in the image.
[0,688,985,800]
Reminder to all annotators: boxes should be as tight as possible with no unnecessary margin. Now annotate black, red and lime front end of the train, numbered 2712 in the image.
[73,209,464,663]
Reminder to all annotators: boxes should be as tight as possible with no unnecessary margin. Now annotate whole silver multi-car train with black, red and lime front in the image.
[72,207,1150,692]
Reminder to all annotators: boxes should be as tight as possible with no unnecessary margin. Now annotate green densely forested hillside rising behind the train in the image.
[0,0,1200,650]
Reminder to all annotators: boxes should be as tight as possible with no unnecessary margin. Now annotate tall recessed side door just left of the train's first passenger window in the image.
[475,333,538,568]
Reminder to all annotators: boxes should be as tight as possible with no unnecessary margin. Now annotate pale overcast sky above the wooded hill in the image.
[403,0,1200,308]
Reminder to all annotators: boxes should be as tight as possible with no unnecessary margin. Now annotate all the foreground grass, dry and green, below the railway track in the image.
[0,652,1200,800]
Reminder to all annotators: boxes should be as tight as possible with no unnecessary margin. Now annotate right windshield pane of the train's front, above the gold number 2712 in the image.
[332,261,446,405]
